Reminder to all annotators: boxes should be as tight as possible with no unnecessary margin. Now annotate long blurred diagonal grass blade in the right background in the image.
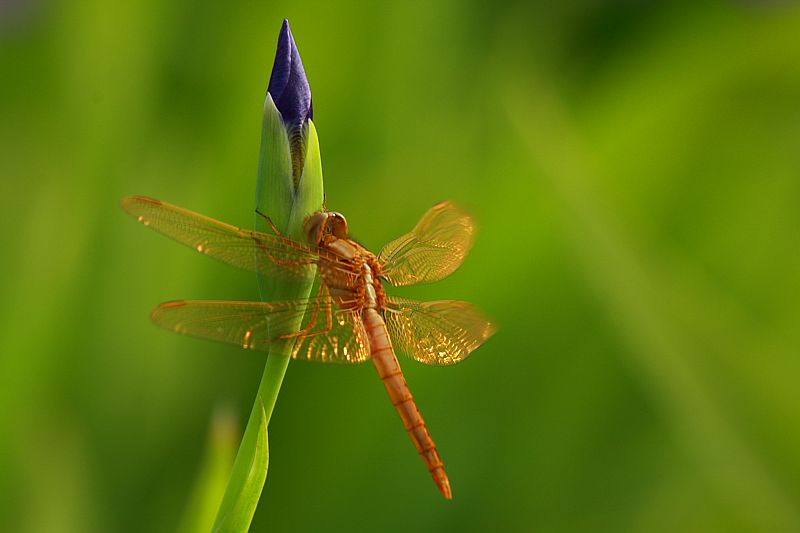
[507,81,800,531]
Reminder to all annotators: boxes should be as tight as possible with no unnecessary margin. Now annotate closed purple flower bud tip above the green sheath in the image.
[267,20,314,129]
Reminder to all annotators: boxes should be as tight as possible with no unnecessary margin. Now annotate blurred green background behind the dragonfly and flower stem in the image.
[0,0,800,532]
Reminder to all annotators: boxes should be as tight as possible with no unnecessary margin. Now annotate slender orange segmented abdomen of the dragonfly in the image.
[364,307,453,500]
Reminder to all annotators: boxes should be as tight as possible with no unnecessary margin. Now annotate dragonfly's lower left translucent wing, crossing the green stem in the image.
[152,290,370,363]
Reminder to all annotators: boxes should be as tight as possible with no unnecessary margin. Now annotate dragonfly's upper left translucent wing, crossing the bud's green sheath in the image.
[122,196,352,279]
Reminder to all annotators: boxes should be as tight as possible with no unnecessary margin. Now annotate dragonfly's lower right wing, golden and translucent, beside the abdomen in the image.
[384,298,497,365]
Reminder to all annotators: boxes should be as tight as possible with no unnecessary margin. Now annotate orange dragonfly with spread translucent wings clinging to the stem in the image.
[122,196,496,499]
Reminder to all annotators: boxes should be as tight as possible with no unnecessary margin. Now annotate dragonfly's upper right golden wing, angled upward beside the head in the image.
[378,202,475,286]
